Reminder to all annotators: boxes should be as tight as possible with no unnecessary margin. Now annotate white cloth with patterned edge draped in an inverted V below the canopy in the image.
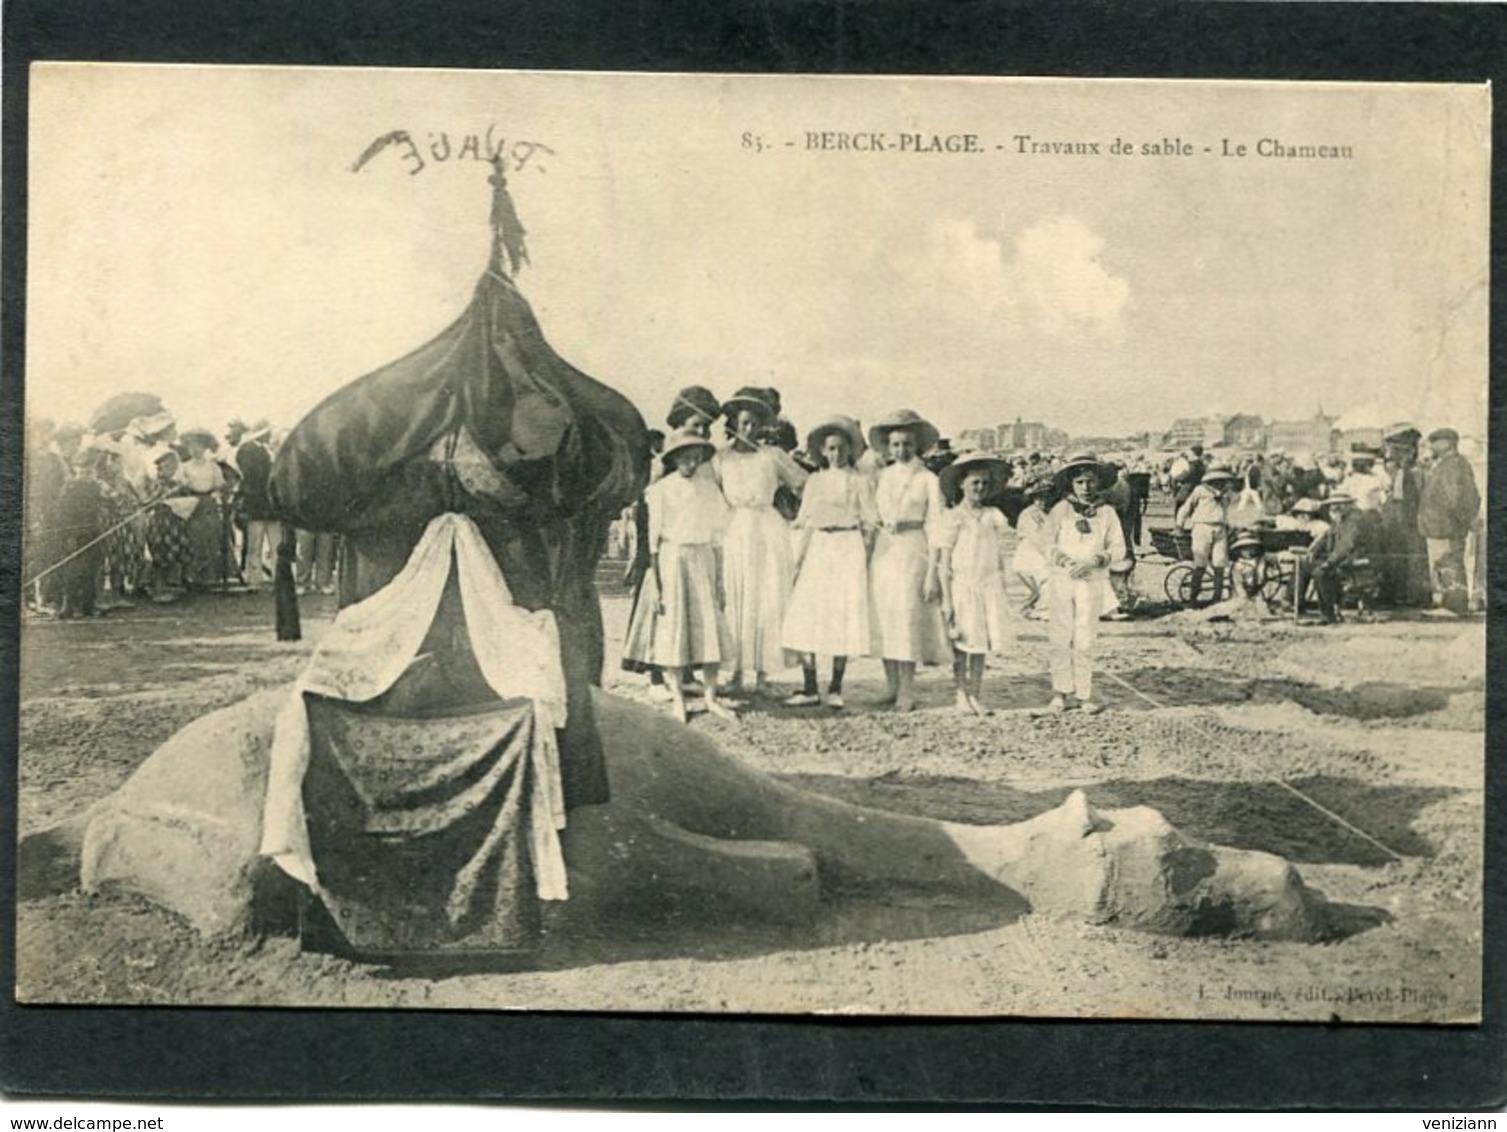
[261,512,568,900]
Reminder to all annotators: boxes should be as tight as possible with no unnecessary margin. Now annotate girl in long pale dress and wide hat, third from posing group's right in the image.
[868,408,951,711]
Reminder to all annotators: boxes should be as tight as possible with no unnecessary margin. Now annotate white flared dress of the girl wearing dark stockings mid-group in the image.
[784,467,879,656]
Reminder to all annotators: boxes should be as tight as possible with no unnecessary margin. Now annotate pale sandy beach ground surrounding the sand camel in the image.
[17,542,1484,1022]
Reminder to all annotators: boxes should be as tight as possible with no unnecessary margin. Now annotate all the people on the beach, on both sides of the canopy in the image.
[27,386,1484,717]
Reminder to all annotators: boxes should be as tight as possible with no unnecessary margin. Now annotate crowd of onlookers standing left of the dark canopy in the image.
[26,411,336,620]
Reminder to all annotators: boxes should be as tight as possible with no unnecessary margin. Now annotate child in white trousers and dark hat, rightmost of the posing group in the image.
[1043,452,1127,714]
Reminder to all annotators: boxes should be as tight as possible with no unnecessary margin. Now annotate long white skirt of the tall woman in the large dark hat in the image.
[722,505,796,672]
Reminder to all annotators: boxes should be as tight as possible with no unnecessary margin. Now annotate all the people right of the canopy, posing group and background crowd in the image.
[608,386,1484,717]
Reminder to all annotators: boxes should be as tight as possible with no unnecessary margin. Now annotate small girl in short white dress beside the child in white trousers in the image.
[939,454,1010,716]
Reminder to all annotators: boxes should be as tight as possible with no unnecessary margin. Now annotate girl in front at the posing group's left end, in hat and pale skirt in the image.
[624,430,735,721]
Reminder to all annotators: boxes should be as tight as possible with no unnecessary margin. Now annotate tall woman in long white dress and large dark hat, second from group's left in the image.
[713,387,806,696]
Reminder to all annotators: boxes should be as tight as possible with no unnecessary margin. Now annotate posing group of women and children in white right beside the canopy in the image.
[624,386,1150,717]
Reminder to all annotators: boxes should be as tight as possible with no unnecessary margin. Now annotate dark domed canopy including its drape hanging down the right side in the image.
[270,270,650,806]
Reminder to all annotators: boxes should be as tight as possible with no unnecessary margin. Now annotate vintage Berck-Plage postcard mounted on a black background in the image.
[15,63,1490,1023]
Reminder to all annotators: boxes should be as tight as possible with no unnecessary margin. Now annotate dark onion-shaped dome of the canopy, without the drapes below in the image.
[271,271,648,553]
